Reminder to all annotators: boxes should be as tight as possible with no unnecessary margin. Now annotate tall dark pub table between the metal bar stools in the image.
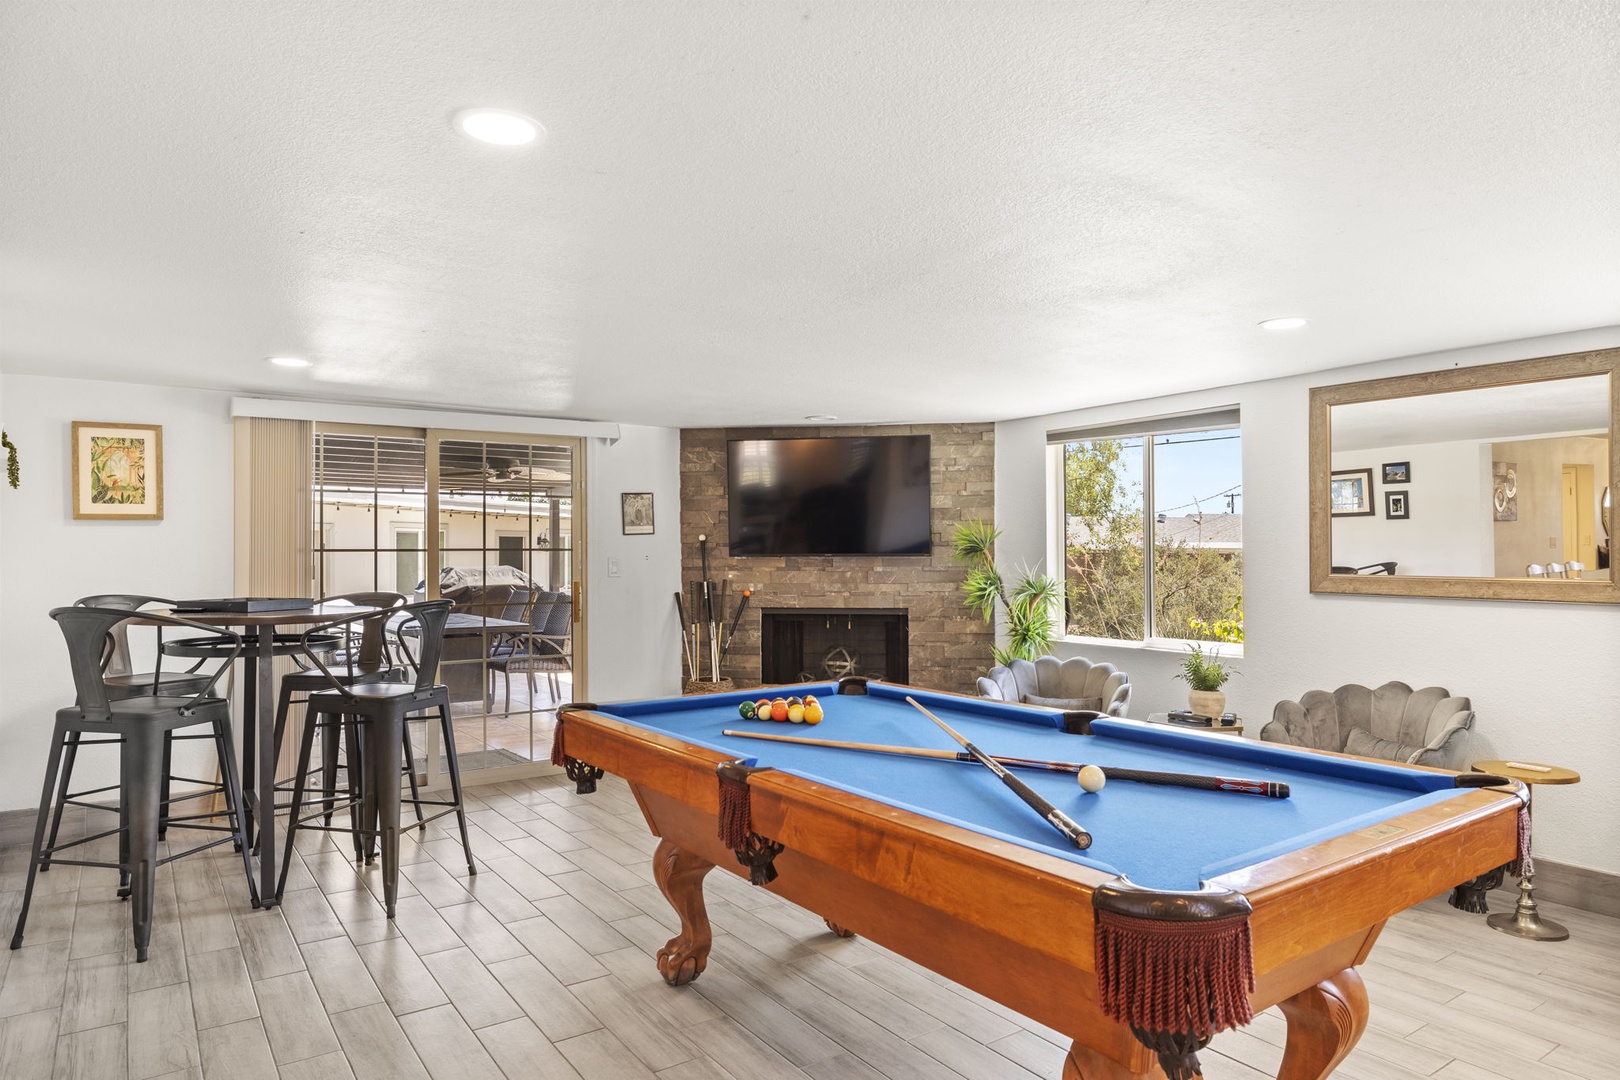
[151,602,386,907]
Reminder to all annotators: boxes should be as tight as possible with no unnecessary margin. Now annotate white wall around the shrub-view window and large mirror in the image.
[996,327,1620,873]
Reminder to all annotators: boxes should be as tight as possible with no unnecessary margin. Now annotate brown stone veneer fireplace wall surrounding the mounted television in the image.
[680,424,995,693]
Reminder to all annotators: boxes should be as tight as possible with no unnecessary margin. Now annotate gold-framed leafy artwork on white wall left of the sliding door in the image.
[71,419,164,521]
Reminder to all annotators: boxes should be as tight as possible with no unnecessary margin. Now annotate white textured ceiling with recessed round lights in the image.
[0,0,1620,426]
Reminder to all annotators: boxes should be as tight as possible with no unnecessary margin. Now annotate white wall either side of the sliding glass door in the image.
[0,376,680,810]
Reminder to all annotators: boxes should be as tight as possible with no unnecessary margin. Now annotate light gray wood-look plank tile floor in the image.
[0,777,1620,1080]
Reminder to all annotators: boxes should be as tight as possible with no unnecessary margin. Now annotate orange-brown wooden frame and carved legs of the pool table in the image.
[559,691,1521,1080]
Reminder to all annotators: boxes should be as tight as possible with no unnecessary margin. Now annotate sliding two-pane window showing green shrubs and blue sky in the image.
[1048,410,1243,643]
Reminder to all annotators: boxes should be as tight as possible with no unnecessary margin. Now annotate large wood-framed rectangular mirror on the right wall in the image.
[1311,348,1620,604]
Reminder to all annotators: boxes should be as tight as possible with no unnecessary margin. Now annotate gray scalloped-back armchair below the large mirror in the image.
[1260,682,1474,769]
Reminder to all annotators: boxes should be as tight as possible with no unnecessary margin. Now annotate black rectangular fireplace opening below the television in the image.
[760,607,910,683]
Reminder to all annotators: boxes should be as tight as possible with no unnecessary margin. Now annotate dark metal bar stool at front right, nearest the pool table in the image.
[279,601,478,918]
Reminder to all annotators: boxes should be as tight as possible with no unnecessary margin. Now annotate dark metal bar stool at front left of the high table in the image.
[11,607,259,962]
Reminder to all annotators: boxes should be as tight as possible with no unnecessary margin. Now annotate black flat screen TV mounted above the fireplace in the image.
[726,436,932,555]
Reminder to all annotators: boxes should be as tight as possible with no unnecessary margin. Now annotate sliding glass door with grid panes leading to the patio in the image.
[311,424,583,782]
